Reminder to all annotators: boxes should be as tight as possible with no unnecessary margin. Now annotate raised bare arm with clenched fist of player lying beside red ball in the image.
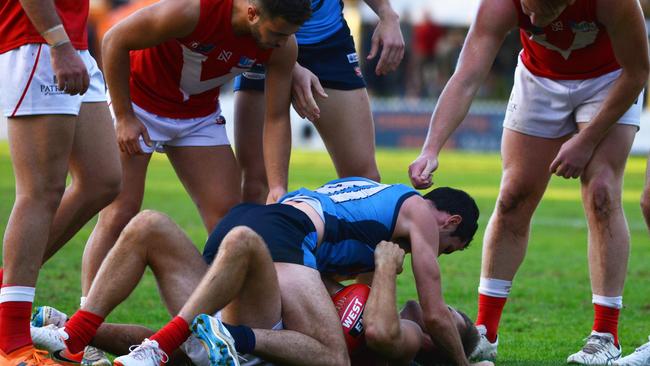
[363,241,422,364]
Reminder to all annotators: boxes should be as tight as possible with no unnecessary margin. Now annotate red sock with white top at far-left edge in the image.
[0,286,36,354]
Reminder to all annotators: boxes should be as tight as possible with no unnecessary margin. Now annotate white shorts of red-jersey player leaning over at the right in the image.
[503,61,643,138]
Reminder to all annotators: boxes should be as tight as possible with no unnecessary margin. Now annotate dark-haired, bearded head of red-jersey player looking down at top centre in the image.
[247,0,311,48]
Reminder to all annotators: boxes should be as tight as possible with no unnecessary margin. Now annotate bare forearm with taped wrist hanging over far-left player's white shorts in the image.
[20,0,90,95]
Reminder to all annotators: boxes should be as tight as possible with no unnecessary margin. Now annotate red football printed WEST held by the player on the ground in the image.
[332,284,370,354]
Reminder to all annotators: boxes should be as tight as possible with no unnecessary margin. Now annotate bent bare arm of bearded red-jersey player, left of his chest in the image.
[102,0,200,154]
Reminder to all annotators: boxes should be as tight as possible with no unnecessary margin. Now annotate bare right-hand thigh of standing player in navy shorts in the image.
[314,88,377,178]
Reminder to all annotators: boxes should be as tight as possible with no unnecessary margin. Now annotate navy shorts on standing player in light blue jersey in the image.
[234,25,366,91]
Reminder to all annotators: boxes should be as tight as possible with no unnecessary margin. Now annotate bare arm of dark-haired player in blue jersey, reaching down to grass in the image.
[393,196,469,365]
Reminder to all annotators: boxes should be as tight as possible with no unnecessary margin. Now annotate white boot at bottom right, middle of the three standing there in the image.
[566,331,621,365]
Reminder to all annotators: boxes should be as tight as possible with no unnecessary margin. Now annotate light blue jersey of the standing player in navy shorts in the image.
[296,0,346,45]
